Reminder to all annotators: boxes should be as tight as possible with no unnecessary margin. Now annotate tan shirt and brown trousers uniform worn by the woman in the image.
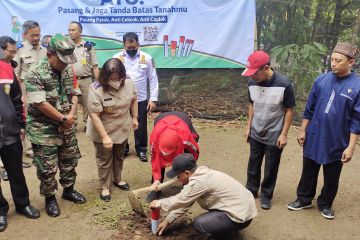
[87,79,137,189]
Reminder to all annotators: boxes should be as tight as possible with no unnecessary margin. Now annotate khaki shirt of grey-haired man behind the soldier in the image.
[14,41,46,81]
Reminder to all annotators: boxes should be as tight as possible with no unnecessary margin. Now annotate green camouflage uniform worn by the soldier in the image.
[25,58,81,196]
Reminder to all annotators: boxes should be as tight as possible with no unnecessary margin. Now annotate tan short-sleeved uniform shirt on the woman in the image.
[87,78,137,144]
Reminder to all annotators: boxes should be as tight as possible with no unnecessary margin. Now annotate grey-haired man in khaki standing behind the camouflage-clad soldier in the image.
[14,21,46,163]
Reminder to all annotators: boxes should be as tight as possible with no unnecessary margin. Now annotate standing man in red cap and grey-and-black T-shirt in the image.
[242,51,295,209]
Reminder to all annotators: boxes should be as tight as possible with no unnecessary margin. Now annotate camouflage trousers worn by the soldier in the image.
[32,131,81,197]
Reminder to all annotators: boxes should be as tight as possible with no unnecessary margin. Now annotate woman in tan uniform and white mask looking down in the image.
[88,58,138,201]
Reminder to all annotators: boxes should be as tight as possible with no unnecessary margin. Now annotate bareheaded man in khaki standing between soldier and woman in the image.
[68,21,99,128]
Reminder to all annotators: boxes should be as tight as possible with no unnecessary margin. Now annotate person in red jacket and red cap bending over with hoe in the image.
[146,112,199,202]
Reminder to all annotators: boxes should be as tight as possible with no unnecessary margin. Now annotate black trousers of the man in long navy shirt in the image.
[297,157,343,210]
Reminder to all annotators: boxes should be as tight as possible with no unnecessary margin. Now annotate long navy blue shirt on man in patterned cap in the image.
[303,72,360,164]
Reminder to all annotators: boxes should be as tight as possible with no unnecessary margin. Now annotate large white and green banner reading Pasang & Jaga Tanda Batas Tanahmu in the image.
[0,0,255,68]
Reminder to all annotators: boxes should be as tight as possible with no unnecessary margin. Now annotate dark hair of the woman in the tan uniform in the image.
[99,58,126,91]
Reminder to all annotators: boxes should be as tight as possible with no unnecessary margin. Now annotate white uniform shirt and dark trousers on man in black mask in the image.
[113,50,159,157]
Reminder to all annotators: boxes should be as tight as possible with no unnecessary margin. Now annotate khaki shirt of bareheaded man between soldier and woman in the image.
[73,40,99,77]
